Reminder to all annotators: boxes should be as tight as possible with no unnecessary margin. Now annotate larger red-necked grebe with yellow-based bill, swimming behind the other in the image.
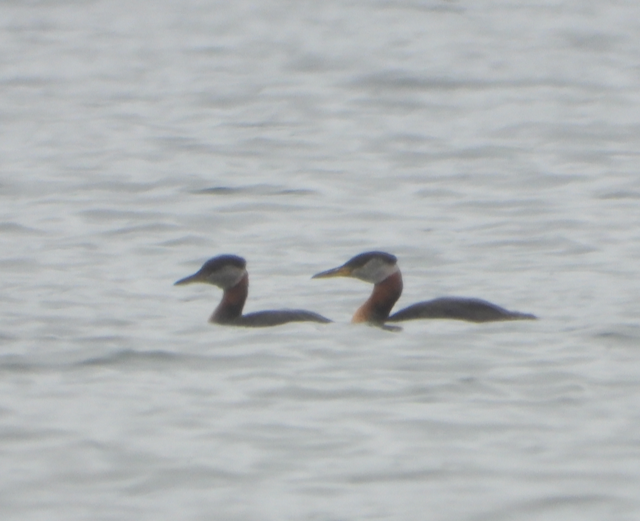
[312,251,536,329]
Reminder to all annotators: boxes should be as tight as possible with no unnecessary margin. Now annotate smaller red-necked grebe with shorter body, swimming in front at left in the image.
[174,255,331,327]
